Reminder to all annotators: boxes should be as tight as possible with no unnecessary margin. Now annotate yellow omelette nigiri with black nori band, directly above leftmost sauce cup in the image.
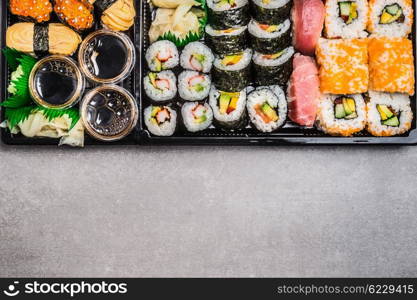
[6,23,81,55]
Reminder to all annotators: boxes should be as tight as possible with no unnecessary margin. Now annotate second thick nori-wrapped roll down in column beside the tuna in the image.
[248,19,291,54]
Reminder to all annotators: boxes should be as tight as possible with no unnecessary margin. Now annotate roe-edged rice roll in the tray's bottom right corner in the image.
[366,91,413,136]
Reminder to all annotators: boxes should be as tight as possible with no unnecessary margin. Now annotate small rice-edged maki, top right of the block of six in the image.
[180,42,214,73]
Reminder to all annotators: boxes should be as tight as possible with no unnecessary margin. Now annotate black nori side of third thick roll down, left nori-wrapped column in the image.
[211,64,251,92]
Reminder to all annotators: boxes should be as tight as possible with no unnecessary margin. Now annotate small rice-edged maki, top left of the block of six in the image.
[145,40,179,72]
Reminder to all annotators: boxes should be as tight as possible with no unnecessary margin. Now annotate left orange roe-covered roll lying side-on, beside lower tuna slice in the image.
[316,39,369,94]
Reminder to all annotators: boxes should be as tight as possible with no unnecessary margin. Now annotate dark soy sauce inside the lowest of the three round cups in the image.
[87,89,132,136]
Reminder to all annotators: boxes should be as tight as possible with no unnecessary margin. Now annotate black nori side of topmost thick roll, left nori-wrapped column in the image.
[208,4,250,30]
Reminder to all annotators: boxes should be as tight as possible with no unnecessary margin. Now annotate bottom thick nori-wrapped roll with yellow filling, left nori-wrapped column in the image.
[209,87,246,129]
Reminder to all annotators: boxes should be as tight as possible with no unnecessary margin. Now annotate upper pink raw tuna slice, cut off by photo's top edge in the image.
[292,0,325,55]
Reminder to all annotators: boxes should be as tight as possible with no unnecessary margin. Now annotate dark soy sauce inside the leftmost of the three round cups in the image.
[34,61,78,106]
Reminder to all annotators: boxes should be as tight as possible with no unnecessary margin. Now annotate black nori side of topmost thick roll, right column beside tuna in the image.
[250,1,292,25]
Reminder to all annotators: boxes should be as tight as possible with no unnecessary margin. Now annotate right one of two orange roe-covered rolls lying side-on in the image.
[369,37,415,95]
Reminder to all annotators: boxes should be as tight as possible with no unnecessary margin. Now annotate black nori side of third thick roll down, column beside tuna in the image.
[253,57,293,86]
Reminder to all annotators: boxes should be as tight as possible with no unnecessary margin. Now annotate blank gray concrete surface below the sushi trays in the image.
[0,146,417,277]
